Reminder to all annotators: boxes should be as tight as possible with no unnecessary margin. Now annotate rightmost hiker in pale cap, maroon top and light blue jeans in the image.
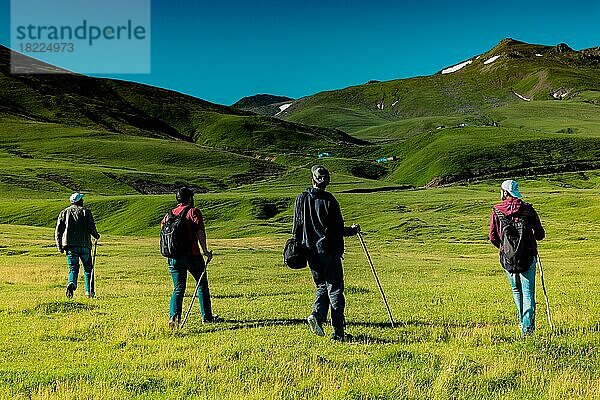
[489,180,546,335]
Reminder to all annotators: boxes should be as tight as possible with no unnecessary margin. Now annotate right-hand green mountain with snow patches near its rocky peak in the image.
[268,39,600,186]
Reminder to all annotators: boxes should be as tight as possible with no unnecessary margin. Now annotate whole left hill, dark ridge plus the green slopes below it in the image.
[0,47,376,202]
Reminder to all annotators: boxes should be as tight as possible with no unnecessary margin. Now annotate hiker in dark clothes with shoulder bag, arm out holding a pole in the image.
[292,165,360,342]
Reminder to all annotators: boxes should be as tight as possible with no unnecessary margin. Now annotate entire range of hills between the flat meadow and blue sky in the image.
[0,39,600,195]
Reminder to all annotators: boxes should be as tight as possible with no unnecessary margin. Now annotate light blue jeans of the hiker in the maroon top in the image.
[506,257,537,335]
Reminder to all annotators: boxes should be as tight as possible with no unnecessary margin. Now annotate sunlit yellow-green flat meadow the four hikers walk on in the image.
[0,176,600,399]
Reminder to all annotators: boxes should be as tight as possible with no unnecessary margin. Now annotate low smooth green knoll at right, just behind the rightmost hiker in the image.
[386,127,600,185]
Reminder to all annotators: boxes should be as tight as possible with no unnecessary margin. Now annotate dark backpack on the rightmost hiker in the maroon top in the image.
[494,207,535,273]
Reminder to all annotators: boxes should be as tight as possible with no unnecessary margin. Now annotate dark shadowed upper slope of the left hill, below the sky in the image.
[0,46,360,151]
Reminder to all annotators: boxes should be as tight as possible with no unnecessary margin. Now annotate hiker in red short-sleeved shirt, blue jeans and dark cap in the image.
[161,187,218,328]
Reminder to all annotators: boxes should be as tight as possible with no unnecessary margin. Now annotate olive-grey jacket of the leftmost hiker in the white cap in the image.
[54,204,100,252]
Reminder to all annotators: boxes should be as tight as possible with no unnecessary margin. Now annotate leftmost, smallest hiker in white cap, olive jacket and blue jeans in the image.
[54,193,100,299]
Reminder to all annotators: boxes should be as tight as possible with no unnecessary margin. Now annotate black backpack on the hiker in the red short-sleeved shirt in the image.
[160,206,192,258]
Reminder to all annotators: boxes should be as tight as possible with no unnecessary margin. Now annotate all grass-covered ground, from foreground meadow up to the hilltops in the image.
[0,39,600,400]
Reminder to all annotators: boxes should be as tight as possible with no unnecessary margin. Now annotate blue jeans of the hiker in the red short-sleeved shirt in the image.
[169,256,212,321]
